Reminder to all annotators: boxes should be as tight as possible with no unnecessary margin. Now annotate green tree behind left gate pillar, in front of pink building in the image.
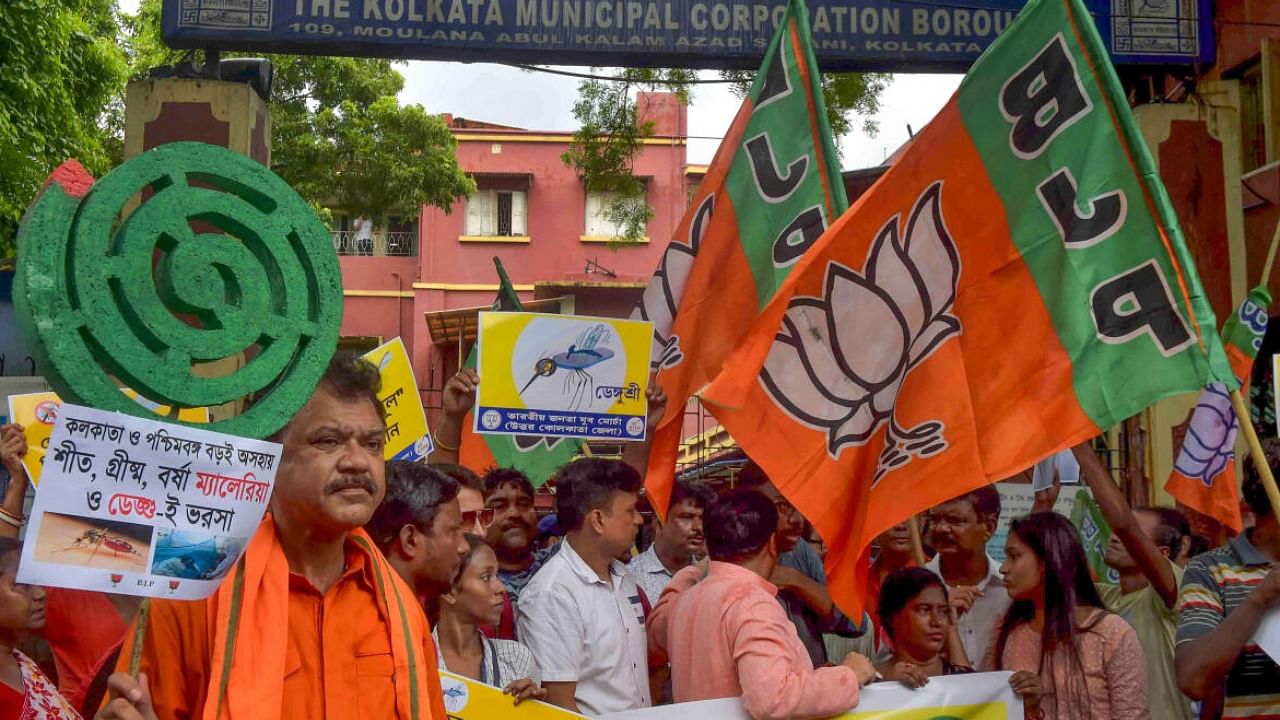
[127,0,475,220]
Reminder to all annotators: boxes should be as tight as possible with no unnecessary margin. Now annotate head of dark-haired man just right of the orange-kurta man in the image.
[365,460,467,621]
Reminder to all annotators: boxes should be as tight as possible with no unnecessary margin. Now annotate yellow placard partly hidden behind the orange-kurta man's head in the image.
[365,338,434,460]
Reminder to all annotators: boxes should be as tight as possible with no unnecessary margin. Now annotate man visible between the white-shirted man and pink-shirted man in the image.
[628,480,716,605]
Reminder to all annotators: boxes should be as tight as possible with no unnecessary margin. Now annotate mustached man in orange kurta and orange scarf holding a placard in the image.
[102,352,447,720]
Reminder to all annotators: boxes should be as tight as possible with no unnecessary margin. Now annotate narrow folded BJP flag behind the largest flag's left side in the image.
[631,0,849,514]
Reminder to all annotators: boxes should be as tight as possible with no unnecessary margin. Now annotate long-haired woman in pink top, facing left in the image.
[987,512,1151,720]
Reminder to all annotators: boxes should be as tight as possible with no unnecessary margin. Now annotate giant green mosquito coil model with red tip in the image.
[13,142,342,430]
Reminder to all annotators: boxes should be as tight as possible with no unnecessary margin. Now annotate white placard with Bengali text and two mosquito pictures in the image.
[18,404,280,600]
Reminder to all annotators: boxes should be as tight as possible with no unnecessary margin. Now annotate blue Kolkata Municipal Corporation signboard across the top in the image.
[164,0,1213,73]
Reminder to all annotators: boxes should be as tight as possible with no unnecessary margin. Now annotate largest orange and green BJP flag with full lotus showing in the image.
[704,0,1236,616]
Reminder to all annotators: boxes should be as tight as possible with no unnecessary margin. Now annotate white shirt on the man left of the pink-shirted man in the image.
[516,538,653,716]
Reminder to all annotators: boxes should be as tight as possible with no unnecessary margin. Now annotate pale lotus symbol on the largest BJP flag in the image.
[760,182,960,480]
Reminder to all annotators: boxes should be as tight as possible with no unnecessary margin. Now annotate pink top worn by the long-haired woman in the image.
[988,604,1151,720]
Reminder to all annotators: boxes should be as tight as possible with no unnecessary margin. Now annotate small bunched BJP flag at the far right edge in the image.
[1165,286,1271,534]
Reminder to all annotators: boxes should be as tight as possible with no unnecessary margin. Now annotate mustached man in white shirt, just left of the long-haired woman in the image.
[925,486,1010,670]
